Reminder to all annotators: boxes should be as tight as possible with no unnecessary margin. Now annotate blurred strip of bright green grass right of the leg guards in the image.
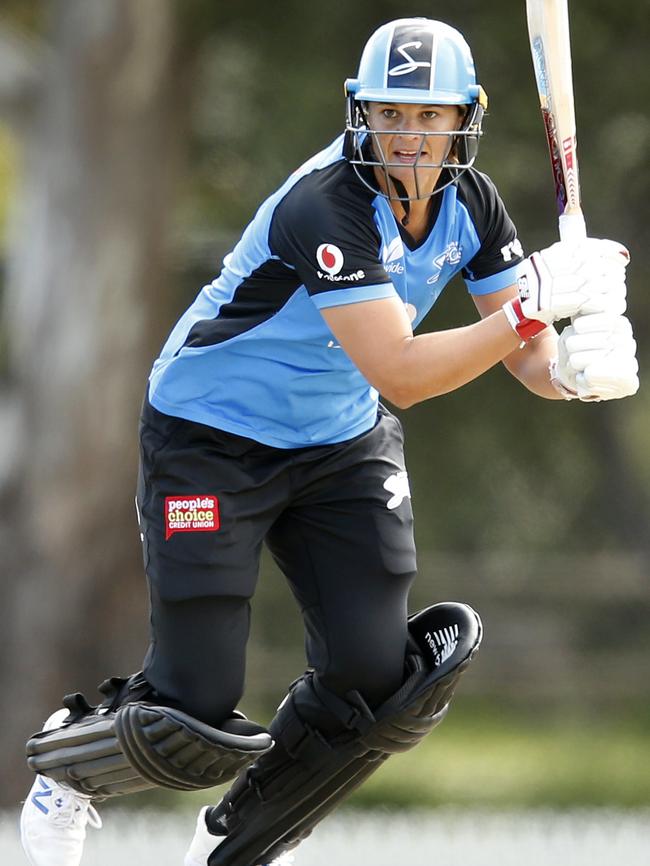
[353,702,650,809]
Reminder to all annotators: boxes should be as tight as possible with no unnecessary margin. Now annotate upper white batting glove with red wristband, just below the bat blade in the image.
[503,238,630,342]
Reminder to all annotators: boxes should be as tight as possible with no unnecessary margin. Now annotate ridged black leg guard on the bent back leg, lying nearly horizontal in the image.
[27,675,273,799]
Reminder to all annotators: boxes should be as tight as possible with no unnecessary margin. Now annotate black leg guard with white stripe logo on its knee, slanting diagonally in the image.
[208,603,482,866]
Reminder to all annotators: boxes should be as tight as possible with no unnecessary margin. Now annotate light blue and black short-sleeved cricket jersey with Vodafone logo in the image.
[149,137,523,448]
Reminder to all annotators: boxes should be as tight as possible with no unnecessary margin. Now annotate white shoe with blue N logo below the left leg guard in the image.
[20,709,102,866]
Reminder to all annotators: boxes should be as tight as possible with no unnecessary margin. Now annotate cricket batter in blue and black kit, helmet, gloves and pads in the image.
[21,18,638,866]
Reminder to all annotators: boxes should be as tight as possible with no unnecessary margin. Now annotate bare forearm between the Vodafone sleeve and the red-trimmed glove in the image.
[380,310,520,409]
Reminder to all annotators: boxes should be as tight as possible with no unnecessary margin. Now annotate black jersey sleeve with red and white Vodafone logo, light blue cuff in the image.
[269,170,396,309]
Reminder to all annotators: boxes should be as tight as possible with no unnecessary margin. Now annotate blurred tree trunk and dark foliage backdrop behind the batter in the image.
[0,0,650,805]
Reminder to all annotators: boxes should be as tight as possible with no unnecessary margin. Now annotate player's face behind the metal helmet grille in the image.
[367,102,464,197]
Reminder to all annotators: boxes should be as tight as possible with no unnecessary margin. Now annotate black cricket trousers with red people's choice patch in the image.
[137,401,416,725]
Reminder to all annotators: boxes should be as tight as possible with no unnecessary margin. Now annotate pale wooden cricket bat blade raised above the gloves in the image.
[526,0,586,240]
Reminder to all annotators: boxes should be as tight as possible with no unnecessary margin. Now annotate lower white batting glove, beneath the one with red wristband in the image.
[551,313,639,401]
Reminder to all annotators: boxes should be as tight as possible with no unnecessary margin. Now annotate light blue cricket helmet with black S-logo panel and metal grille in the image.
[345,18,487,199]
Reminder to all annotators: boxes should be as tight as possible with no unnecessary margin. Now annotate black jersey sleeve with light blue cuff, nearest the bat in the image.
[462,172,524,295]
